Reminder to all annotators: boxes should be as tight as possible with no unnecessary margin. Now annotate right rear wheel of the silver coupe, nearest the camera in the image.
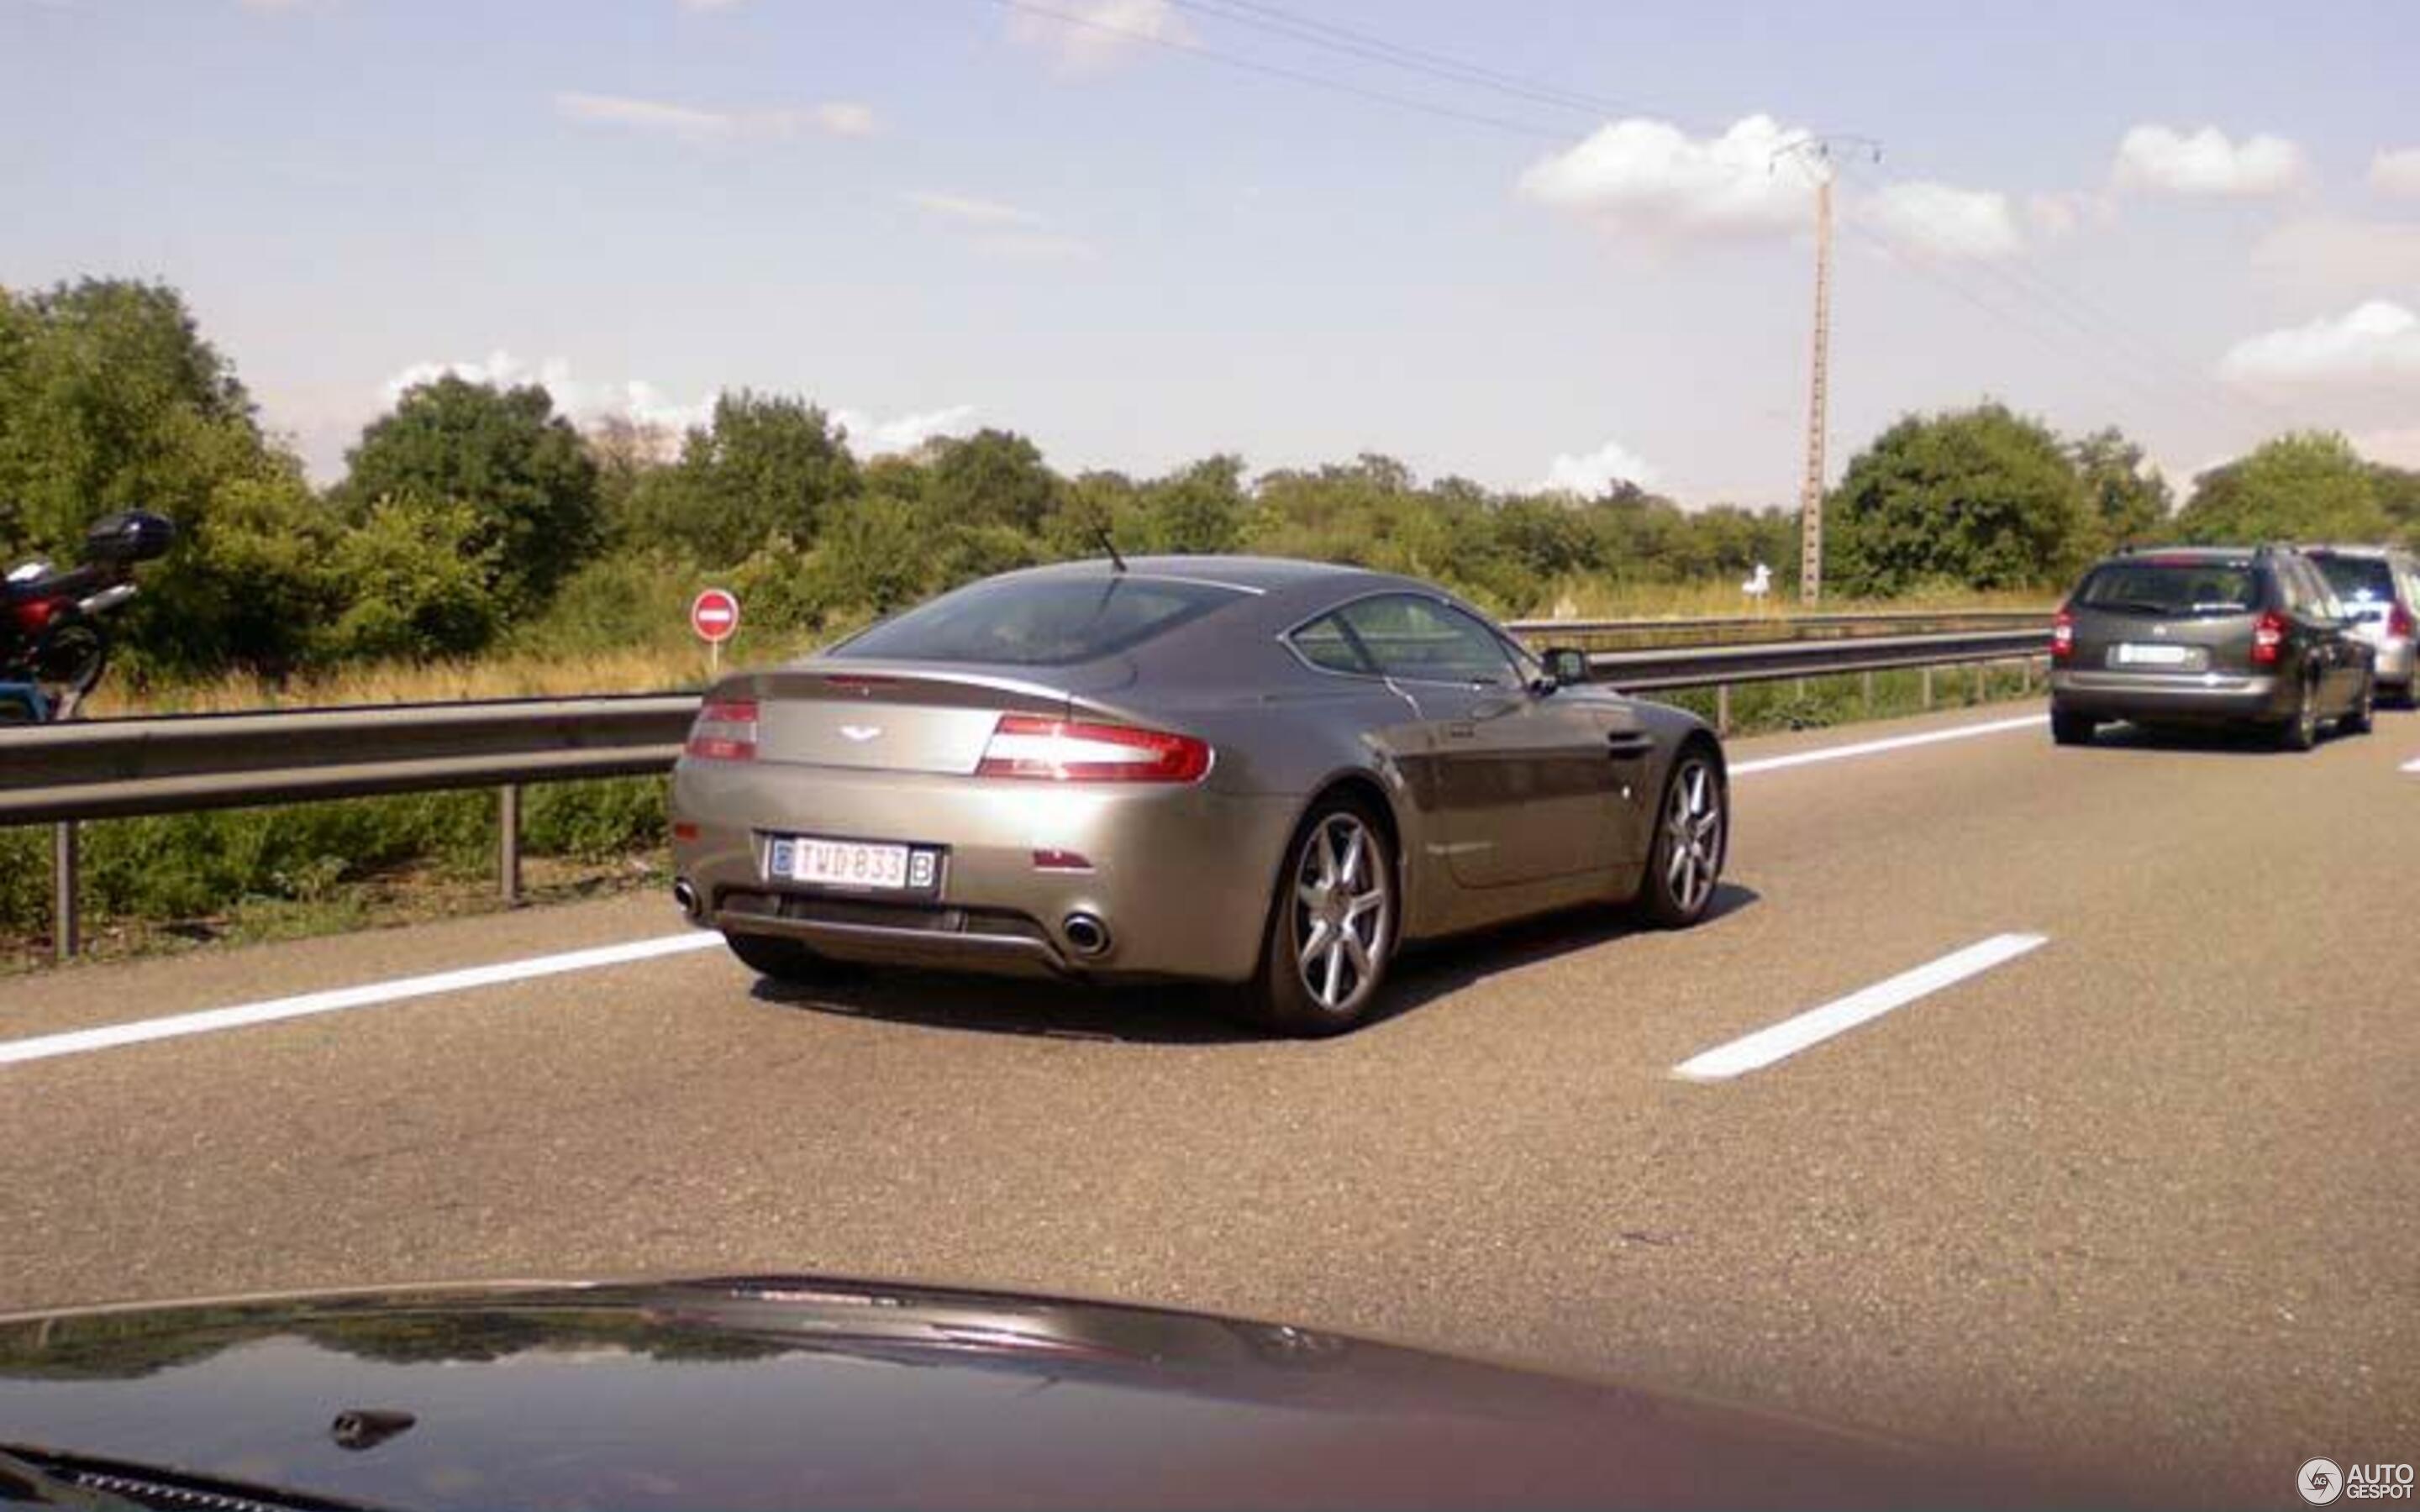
[1241,796,1402,1038]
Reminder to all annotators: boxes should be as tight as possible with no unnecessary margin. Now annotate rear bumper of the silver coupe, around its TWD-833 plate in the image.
[673,759,1300,982]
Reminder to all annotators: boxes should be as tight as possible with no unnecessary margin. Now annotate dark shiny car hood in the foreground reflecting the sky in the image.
[0,1278,2057,1507]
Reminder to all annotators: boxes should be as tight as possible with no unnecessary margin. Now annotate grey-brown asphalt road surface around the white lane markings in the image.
[0,709,2420,1504]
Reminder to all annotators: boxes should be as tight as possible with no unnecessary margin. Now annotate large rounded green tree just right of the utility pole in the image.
[1827,404,2093,595]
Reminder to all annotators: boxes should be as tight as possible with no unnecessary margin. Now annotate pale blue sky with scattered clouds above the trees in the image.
[0,0,2420,503]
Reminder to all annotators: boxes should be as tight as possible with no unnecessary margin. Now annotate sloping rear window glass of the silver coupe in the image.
[830,574,1249,668]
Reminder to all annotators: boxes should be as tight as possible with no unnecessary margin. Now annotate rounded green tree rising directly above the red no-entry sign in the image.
[619,390,857,564]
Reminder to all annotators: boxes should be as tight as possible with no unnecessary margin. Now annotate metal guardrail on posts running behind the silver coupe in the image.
[0,615,2049,958]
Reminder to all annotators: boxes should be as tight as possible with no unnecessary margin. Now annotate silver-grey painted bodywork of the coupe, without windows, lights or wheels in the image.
[673,556,1721,982]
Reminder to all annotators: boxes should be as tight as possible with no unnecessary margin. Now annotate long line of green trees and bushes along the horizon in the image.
[0,278,2420,677]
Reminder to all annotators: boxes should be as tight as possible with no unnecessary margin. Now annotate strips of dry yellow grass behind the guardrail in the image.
[90,583,2049,718]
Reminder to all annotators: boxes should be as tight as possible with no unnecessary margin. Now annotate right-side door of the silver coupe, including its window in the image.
[1339,593,1619,888]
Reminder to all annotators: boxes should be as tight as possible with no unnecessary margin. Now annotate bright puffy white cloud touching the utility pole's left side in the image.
[1520,116,1815,237]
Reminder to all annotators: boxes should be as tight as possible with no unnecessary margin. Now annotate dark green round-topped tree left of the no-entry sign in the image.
[339,373,600,615]
